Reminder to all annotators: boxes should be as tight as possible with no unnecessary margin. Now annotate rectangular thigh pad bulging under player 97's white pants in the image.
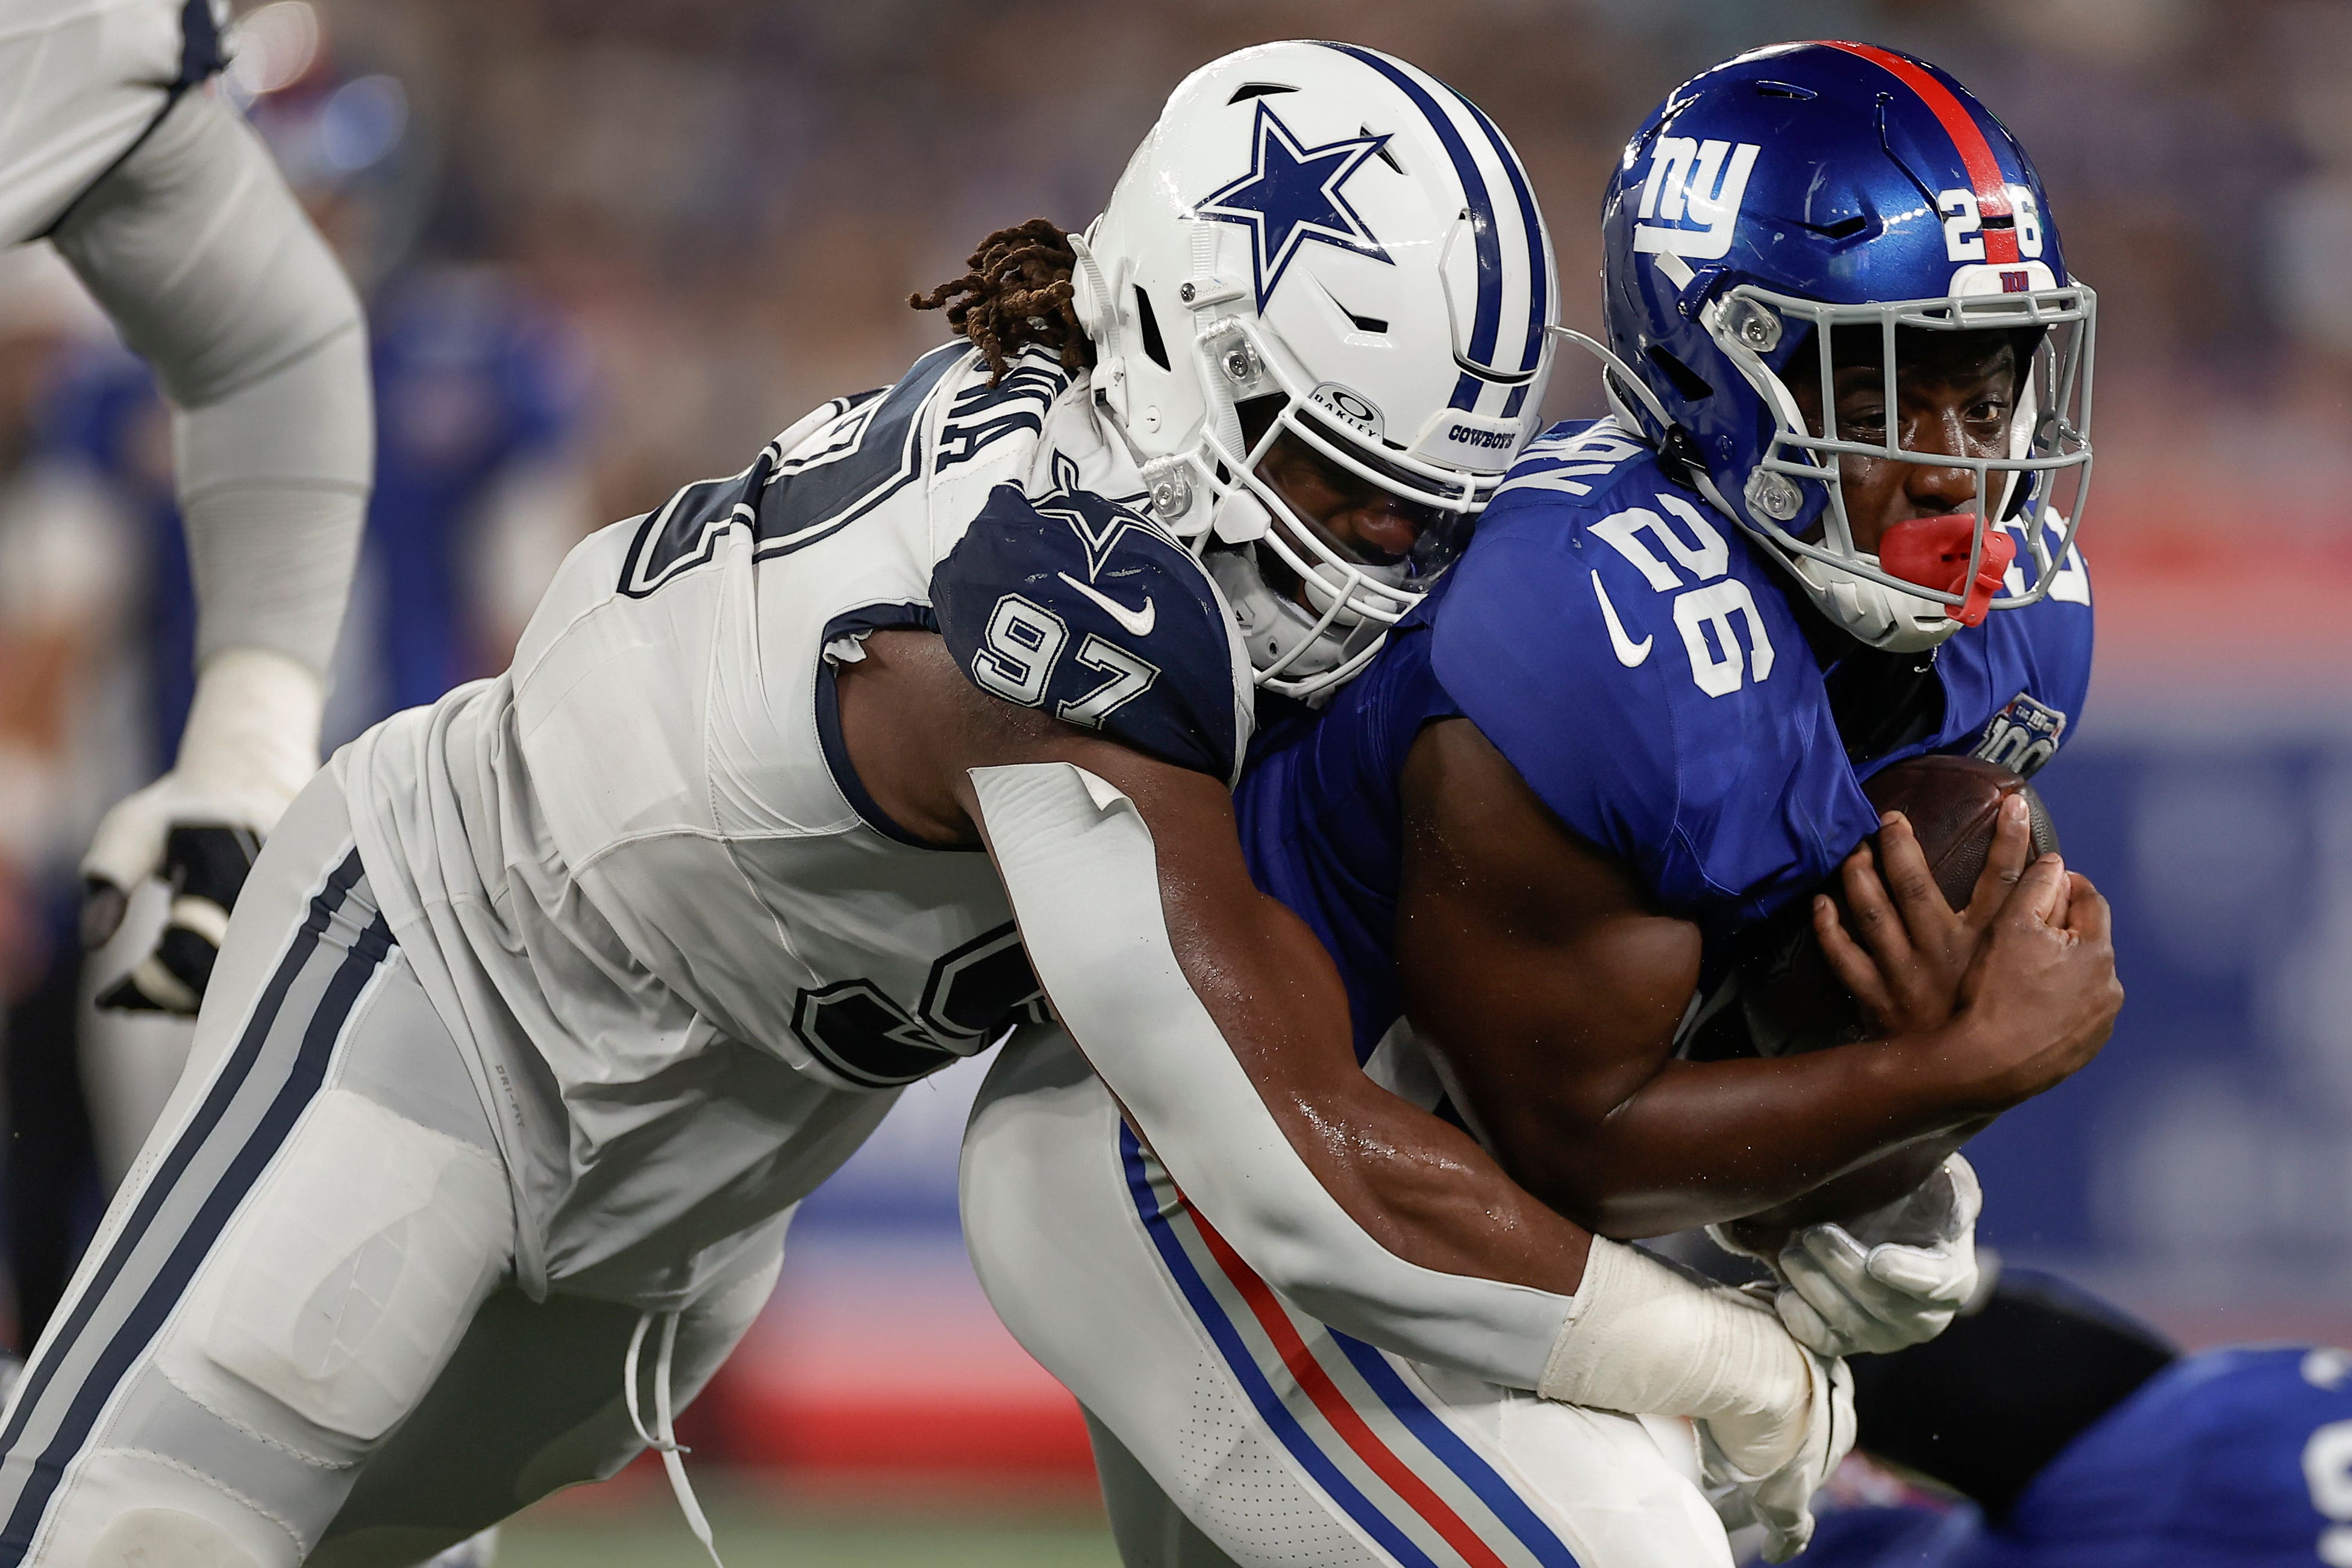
[162,1089,513,1462]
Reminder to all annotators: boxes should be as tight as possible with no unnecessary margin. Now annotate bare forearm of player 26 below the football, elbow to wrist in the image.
[1493,1042,1978,1237]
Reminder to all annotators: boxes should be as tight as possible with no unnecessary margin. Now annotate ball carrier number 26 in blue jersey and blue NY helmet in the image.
[965,42,2119,1563]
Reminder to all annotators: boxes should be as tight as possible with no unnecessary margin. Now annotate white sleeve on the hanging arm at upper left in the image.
[57,92,377,672]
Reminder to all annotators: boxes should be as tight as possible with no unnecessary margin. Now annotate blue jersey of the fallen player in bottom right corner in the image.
[1804,1347,2352,1568]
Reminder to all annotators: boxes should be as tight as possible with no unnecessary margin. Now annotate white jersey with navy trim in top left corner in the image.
[0,0,228,247]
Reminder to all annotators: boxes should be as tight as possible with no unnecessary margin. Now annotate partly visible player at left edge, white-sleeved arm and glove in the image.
[0,0,374,1013]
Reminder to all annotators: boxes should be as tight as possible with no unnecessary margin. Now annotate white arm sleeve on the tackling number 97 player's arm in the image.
[971,761,1580,1389]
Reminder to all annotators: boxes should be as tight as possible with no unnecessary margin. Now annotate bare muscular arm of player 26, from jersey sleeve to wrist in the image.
[1397,719,1988,1237]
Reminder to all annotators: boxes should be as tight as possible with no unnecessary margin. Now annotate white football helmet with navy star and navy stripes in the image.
[1072,42,1559,698]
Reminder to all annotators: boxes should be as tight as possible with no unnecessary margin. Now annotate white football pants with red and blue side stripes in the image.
[962,1027,1731,1568]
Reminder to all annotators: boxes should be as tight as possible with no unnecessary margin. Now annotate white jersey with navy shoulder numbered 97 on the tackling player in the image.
[334,343,1251,1305]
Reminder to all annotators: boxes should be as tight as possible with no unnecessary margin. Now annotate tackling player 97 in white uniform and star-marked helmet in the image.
[0,45,1851,1568]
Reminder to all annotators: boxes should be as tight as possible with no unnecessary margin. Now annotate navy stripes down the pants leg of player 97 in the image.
[0,851,374,1566]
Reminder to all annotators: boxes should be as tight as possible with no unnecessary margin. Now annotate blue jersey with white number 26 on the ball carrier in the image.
[1237,421,2091,1053]
